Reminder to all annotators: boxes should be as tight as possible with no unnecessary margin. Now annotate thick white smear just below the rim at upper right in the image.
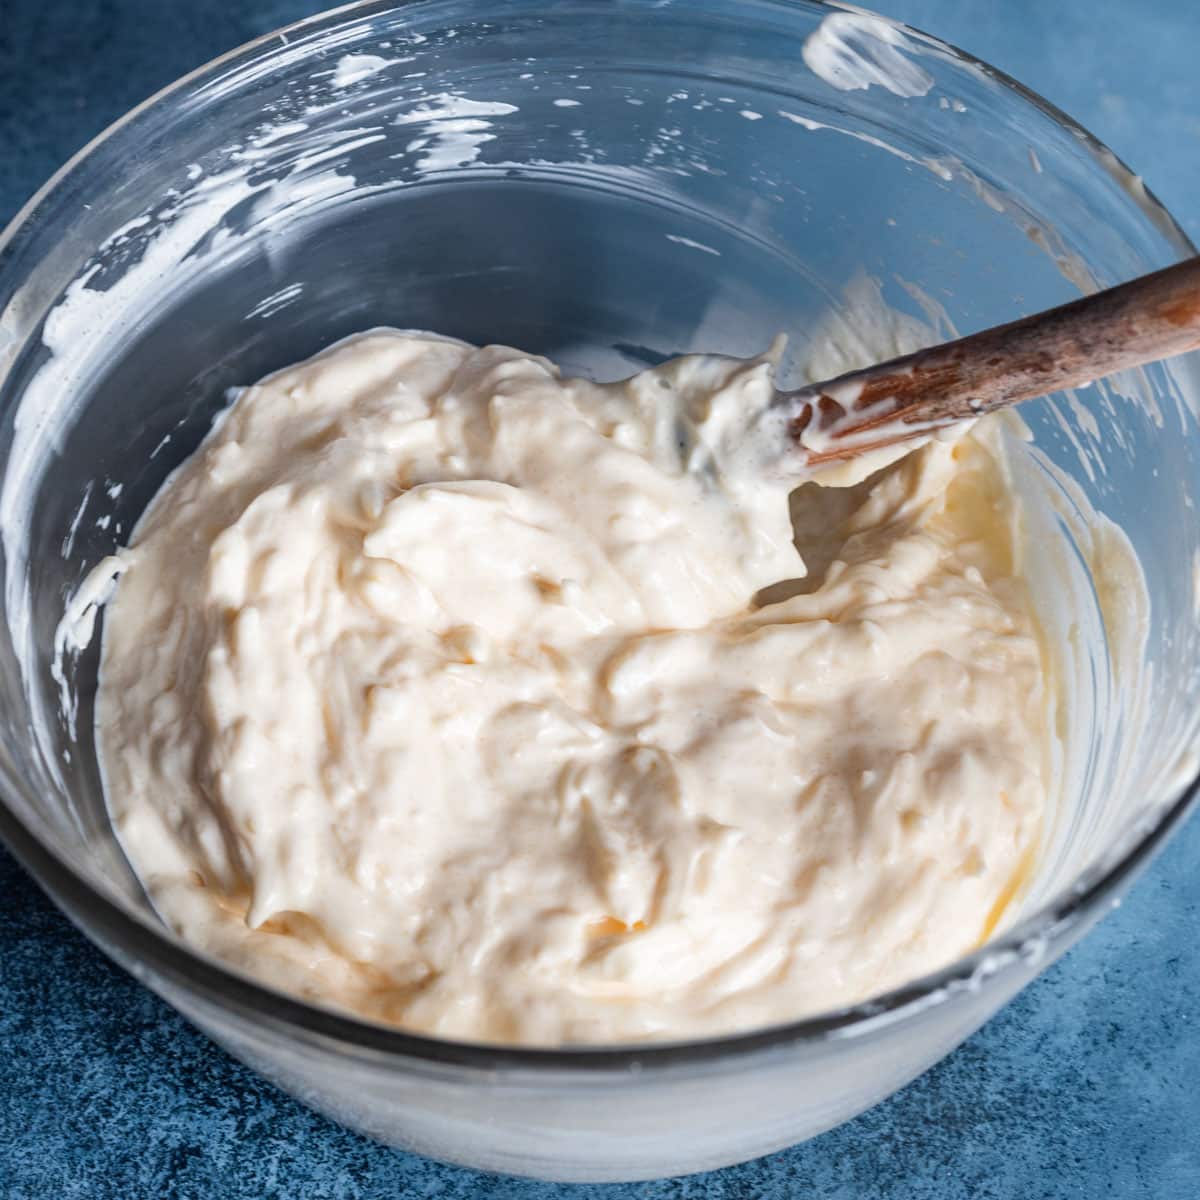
[800,12,934,97]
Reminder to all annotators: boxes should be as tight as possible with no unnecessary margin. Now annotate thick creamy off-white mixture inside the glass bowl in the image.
[88,330,1048,1043]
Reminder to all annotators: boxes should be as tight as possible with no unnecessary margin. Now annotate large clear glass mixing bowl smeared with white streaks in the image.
[0,0,1200,1180]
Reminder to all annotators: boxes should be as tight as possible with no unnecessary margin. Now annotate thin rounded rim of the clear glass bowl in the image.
[0,0,1200,1076]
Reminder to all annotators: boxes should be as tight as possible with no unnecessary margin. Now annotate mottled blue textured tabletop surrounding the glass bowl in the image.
[0,0,1200,1200]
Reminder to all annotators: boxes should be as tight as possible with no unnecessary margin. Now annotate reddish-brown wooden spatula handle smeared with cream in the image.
[780,258,1200,466]
